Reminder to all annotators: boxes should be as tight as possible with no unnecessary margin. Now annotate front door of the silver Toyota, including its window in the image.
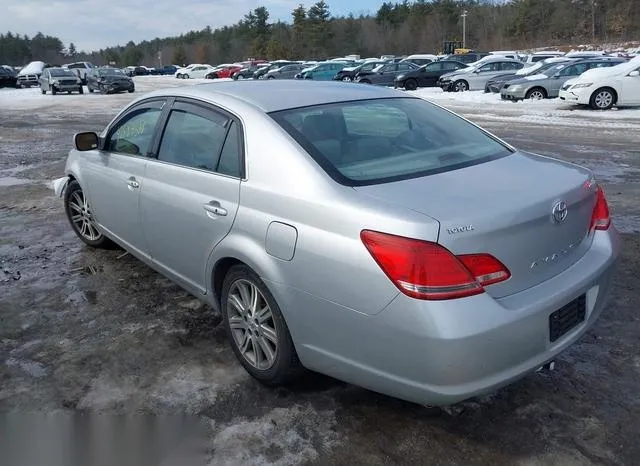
[82,99,165,255]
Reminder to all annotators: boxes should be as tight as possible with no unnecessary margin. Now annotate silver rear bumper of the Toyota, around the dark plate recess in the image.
[285,226,620,405]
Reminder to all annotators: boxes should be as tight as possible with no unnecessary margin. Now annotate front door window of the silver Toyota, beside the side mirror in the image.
[105,108,161,156]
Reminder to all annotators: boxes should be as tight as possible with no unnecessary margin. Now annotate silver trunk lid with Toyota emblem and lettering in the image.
[354,152,596,298]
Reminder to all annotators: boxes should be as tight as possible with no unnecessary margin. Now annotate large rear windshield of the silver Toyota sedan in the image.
[271,97,512,186]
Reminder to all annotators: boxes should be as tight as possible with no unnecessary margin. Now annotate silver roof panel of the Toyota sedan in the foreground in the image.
[148,79,407,113]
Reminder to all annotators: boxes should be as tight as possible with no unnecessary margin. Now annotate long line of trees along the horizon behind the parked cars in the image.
[0,0,640,66]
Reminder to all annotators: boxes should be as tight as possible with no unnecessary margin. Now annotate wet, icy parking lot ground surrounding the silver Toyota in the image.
[0,77,640,466]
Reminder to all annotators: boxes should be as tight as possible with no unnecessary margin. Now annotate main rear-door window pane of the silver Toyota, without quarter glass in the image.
[158,109,231,171]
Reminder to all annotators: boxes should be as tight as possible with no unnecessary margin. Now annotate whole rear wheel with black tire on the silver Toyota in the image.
[220,265,303,386]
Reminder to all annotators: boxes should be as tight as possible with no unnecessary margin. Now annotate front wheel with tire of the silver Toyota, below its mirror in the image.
[64,180,113,248]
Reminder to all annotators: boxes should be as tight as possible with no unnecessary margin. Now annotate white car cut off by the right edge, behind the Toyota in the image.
[559,57,640,110]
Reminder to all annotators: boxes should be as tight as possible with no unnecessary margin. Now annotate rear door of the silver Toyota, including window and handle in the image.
[140,100,244,293]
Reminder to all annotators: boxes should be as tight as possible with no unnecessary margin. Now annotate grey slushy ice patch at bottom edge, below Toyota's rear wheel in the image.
[209,406,340,466]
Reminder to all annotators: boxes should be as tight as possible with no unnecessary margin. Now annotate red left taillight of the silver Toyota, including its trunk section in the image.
[360,230,511,300]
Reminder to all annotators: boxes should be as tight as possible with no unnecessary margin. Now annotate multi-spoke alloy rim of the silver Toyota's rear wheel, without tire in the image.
[226,279,278,370]
